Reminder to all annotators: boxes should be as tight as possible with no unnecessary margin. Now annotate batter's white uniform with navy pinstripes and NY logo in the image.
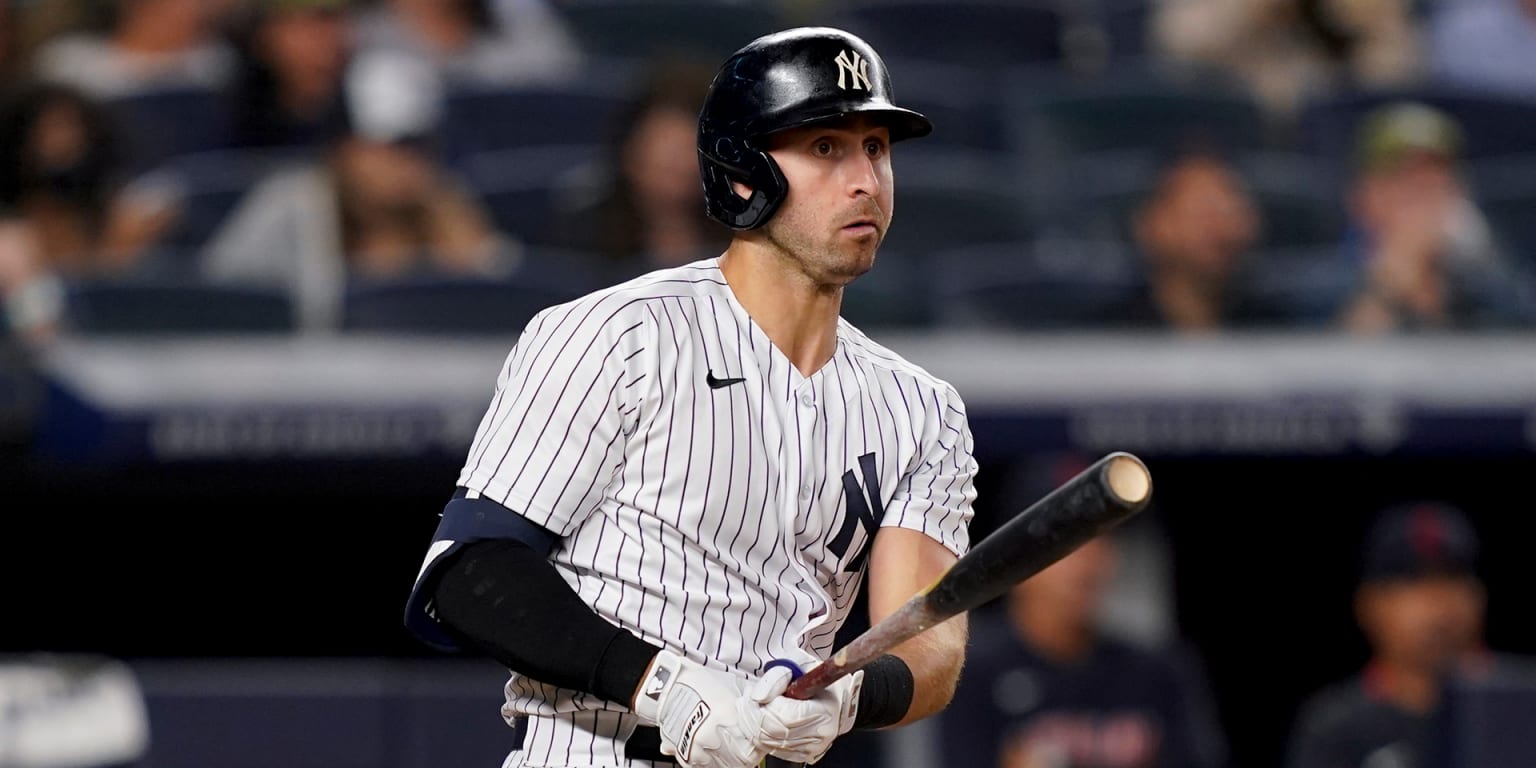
[458,260,975,766]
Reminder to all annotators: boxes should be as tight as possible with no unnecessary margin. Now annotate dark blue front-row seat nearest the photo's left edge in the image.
[65,280,296,335]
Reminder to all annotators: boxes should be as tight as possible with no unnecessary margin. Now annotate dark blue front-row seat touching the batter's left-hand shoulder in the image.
[341,262,591,335]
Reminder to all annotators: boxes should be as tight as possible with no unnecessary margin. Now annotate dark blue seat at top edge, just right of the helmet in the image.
[825,0,1064,67]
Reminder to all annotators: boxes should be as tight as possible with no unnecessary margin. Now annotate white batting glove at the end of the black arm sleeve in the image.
[634,651,763,768]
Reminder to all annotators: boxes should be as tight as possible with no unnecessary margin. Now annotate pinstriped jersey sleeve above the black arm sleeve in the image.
[458,300,656,536]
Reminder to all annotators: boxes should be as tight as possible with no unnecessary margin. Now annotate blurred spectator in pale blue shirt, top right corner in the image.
[1430,0,1536,98]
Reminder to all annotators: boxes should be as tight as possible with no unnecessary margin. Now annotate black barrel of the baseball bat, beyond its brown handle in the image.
[923,452,1152,617]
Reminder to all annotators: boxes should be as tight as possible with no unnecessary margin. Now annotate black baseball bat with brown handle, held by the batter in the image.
[785,452,1152,699]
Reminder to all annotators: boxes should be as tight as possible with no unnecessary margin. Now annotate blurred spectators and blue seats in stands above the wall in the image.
[0,0,1536,339]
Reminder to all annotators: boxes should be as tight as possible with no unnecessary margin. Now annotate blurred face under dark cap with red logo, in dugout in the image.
[1356,576,1484,671]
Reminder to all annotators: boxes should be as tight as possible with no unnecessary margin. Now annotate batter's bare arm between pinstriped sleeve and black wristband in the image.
[866,527,966,725]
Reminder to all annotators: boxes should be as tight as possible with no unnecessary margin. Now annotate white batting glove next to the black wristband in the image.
[750,667,863,763]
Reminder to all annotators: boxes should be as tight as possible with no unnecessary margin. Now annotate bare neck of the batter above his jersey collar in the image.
[720,240,842,376]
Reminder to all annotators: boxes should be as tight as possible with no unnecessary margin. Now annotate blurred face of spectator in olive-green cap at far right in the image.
[1355,152,1462,233]
